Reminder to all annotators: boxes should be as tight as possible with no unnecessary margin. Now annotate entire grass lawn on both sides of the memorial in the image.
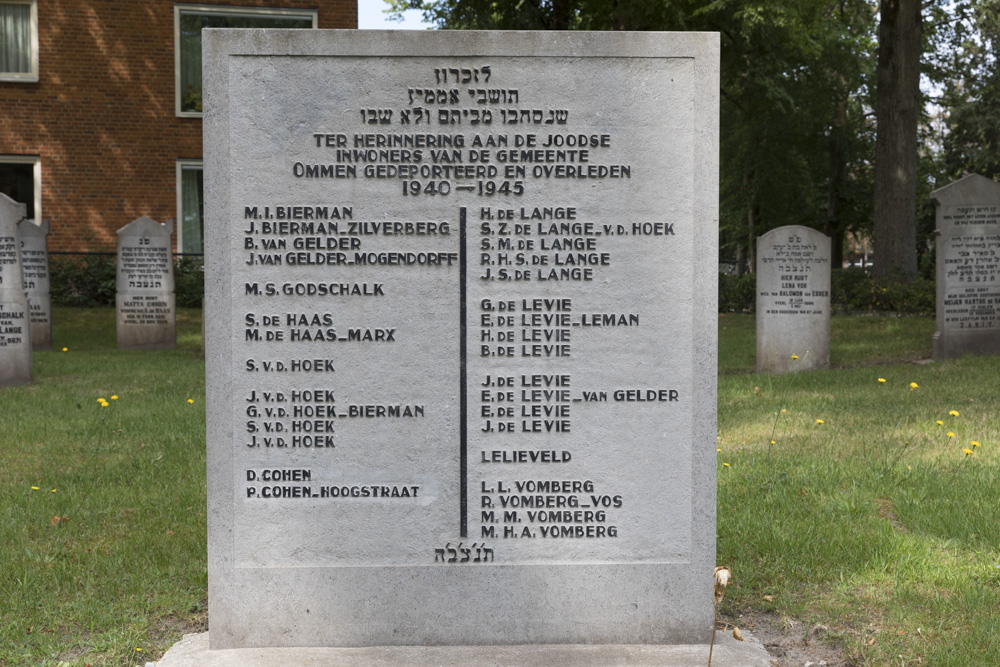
[0,308,1000,667]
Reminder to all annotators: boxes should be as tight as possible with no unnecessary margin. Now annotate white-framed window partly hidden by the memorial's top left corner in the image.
[174,5,317,117]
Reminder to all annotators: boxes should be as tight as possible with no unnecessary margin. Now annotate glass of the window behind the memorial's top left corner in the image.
[177,12,312,111]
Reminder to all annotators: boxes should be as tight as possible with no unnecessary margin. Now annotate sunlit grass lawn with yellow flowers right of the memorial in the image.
[718,315,1000,666]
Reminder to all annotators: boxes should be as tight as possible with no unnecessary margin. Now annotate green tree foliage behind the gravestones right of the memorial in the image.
[386,0,1000,270]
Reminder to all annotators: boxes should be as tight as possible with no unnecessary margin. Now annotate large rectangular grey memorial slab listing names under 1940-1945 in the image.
[204,30,718,649]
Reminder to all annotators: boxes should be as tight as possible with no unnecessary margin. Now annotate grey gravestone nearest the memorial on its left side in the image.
[115,216,177,350]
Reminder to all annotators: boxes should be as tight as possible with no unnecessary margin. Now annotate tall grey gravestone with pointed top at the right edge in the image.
[931,174,1000,359]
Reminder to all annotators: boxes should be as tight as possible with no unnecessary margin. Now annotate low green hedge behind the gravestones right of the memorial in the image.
[719,268,936,315]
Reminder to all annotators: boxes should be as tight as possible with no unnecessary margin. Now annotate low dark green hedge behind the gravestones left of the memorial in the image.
[49,255,205,308]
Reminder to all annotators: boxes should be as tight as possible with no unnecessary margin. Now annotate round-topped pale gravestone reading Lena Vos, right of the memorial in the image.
[757,225,830,373]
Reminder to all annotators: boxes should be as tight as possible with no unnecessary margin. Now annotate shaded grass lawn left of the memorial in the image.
[0,308,207,666]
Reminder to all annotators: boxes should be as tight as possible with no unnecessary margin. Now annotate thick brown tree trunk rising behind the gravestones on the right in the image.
[872,0,921,281]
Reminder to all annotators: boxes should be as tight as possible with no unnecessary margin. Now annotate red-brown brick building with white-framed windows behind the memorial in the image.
[0,0,357,252]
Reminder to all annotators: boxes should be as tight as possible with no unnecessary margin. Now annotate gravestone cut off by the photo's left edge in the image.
[0,194,32,386]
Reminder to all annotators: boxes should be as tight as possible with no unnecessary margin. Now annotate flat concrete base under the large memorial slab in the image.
[154,632,772,667]
